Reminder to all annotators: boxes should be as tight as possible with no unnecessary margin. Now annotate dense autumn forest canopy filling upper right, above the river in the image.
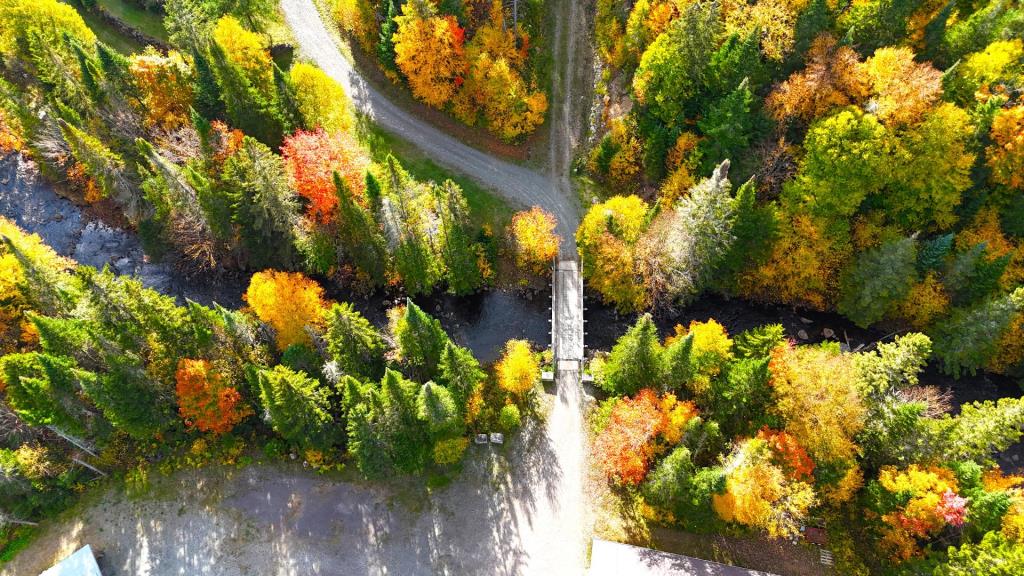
[577,0,1024,375]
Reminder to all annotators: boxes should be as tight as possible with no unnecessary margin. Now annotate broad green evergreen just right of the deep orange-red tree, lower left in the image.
[257,365,335,450]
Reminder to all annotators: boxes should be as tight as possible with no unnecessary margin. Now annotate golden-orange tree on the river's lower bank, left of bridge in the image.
[243,270,327,351]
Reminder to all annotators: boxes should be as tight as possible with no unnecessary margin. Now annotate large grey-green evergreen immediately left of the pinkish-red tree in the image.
[222,136,299,269]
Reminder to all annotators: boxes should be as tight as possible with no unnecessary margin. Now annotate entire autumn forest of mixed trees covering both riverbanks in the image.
[0,0,1024,576]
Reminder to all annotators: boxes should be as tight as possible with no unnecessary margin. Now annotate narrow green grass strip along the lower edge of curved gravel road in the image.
[358,121,514,235]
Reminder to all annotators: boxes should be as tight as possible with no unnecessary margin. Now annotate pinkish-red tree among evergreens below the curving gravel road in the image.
[281,129,370,223]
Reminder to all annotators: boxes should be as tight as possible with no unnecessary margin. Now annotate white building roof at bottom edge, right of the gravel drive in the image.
[588,538,773,576]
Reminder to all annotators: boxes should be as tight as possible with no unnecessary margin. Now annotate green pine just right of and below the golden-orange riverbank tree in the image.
[324,302,385,380]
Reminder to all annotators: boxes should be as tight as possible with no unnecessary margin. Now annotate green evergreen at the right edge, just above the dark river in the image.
[932,288,1024,377]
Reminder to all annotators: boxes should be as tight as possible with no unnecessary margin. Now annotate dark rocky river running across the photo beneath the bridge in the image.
[0,155,1024,470]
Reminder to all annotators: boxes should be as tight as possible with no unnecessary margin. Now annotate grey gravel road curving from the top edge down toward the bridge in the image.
[281,0,580,245]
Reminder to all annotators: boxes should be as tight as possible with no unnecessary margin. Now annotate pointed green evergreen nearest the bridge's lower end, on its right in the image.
[600,314,666,396]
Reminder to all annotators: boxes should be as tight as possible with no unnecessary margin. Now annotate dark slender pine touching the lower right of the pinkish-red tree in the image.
[334,172,387,286]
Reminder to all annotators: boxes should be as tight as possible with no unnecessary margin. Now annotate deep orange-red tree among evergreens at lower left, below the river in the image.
[174,358,252,434]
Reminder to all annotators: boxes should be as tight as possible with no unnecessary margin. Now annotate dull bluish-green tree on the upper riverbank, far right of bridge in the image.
[837,238,918,328]
